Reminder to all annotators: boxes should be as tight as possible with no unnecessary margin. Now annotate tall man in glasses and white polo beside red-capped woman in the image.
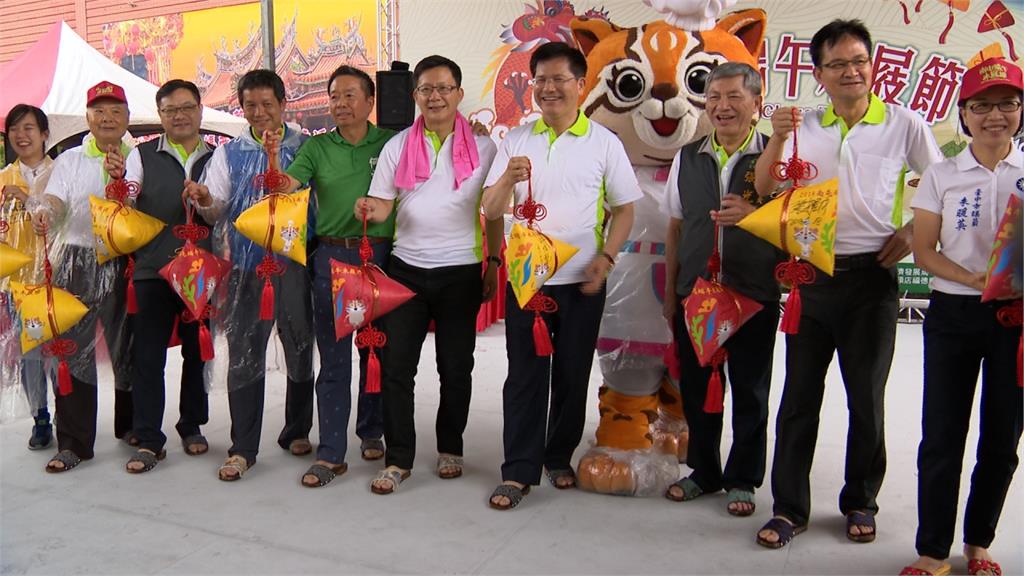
[756,20,942,548]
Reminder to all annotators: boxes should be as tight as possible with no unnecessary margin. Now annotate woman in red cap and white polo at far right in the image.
[901,58,1024,575]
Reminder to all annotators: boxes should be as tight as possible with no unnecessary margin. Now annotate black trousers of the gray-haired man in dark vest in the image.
[676,297,778,492]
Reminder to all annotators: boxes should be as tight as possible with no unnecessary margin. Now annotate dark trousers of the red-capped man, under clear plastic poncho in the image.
[54,245,132,459]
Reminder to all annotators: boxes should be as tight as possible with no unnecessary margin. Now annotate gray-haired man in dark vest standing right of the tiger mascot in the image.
[665,63,780,516]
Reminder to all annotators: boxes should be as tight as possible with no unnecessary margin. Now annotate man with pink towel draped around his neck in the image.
[353,55,503,494]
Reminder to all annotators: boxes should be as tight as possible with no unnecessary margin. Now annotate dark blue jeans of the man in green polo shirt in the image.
[312,242,391,464]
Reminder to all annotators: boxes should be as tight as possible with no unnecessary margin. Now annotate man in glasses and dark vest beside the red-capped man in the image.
[110,80,212,474]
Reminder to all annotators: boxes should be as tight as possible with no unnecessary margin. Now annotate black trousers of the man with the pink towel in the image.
[381,256,483,469]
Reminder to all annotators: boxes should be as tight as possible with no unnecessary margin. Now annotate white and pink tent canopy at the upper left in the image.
[0,22,247,147]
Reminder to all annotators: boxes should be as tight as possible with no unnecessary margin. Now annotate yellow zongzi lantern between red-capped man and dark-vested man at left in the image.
[89,195,165,263]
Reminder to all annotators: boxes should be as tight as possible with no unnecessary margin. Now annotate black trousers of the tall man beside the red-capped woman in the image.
[771,258,899,525]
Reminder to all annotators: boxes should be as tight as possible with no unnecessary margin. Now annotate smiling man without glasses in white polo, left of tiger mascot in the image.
[483,42,642,509]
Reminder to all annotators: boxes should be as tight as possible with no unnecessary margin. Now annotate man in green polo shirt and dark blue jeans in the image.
[286,66,394,488]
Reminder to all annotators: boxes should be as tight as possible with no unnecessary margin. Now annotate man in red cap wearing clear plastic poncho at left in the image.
[30,82,132,472]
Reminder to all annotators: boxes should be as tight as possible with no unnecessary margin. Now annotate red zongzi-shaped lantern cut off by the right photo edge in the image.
[981,195,1024,302]
